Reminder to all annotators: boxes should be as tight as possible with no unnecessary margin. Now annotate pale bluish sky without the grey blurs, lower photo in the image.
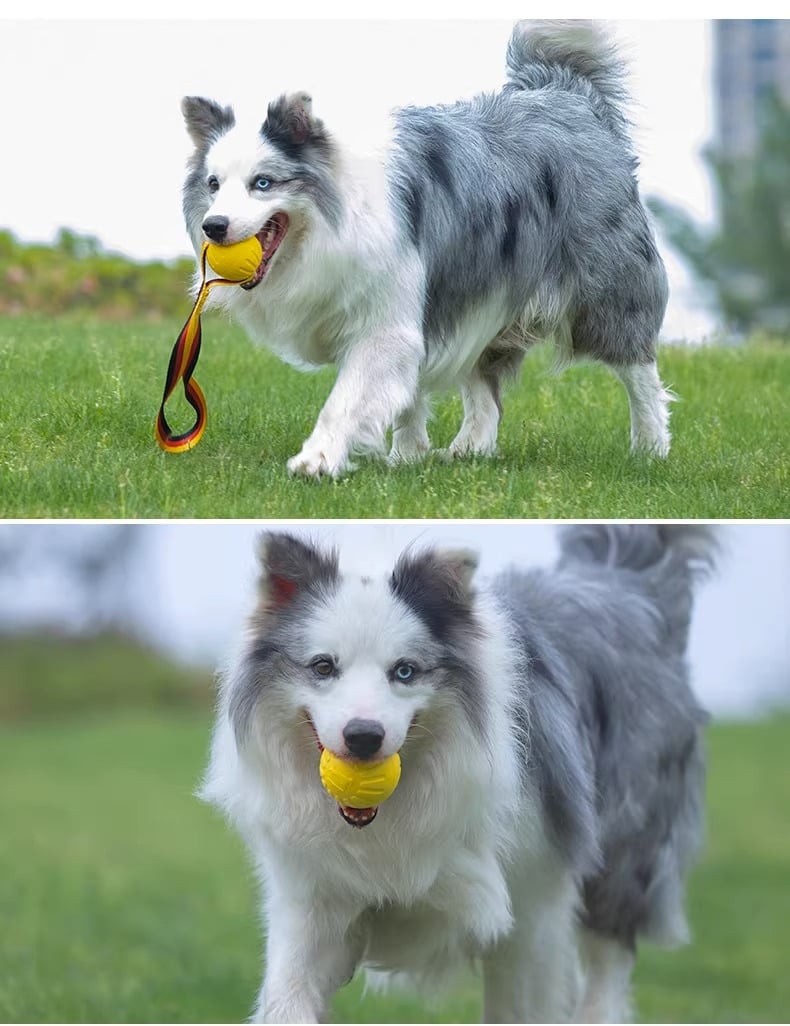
[0,521,790,717]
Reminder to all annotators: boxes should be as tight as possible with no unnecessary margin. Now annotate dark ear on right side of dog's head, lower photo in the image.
[390,549,477,641]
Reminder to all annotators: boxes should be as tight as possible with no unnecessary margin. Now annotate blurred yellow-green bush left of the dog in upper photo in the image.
[0,228,195,320]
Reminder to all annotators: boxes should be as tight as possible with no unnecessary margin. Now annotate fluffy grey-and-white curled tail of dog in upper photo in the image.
[506,21,628,136]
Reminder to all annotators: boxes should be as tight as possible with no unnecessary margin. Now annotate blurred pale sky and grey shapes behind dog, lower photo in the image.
[0,521,790,717]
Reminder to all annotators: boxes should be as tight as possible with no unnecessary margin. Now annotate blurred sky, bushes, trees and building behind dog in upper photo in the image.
[0,18,790,344]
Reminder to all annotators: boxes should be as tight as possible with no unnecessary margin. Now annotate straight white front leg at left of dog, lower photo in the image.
[252,894,362,1023]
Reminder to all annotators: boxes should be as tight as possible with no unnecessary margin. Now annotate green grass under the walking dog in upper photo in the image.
[0,309,790,518]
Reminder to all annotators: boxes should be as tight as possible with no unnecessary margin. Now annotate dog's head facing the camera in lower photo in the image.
[228,534,483,820]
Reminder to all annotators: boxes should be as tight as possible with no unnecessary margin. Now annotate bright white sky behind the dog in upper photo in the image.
[0,17,723,341]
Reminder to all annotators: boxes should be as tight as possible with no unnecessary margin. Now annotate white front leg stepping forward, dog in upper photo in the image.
[288,328,423,477]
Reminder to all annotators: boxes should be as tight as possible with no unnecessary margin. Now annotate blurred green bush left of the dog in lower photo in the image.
[0,633,214,722]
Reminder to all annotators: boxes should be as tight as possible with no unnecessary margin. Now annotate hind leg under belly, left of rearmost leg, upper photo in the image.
[447,347,524,457]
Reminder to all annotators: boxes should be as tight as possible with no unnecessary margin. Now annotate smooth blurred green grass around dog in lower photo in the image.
[0,642,790,1022]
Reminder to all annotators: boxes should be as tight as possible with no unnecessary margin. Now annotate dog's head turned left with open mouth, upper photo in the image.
[182,92,340,289]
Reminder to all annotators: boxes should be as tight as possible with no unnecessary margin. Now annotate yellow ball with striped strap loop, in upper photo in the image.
[156,235,263,452]
